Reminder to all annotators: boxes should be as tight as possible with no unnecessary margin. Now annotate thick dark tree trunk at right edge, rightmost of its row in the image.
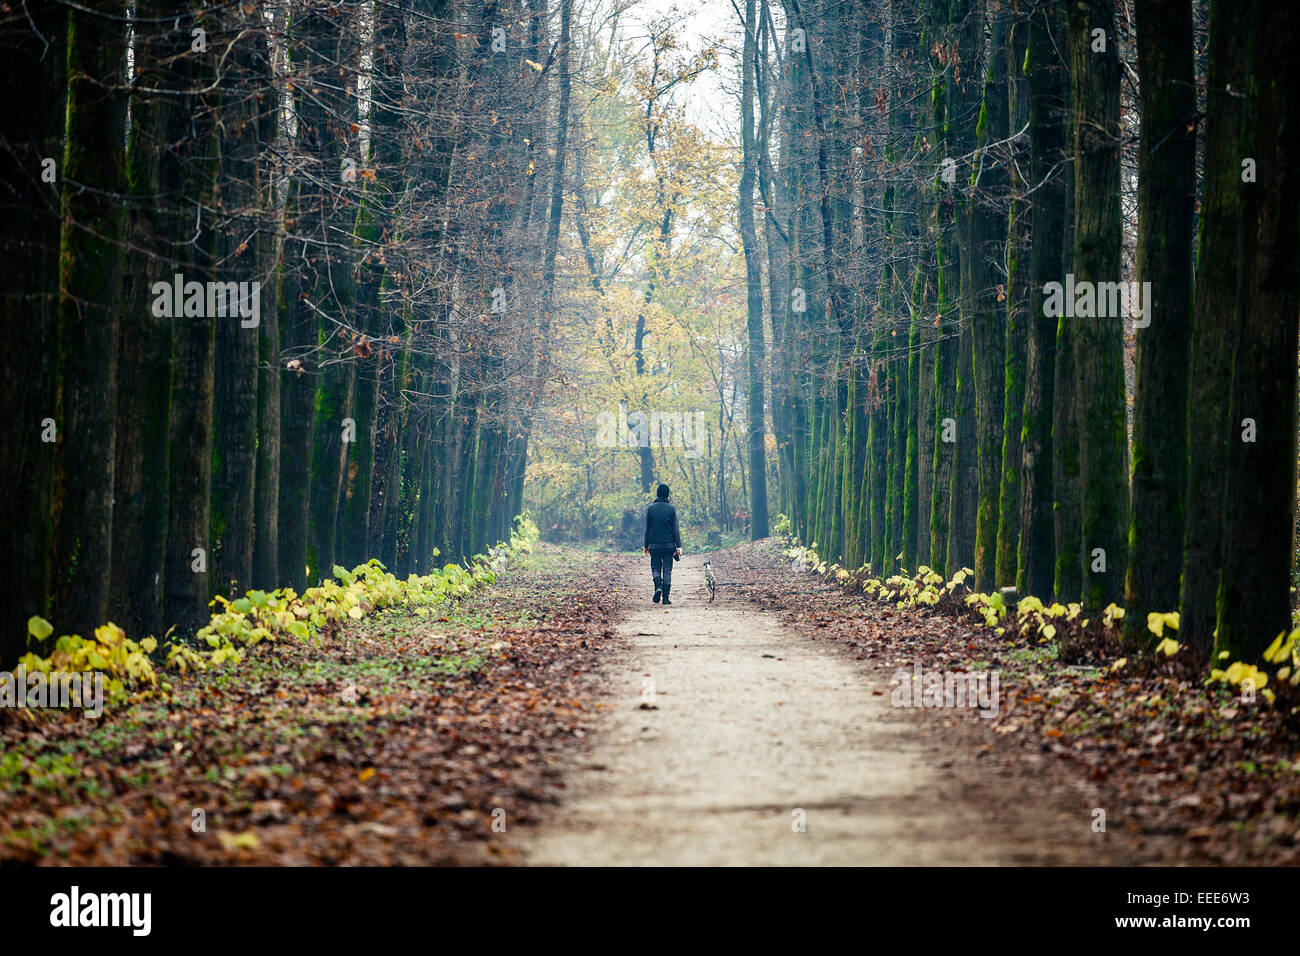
[1216,1,1300,661]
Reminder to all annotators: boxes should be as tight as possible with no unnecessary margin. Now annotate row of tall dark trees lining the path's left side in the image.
[0,0,572,659]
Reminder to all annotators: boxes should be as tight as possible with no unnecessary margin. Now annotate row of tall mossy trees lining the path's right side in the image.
[740,0,1300,657]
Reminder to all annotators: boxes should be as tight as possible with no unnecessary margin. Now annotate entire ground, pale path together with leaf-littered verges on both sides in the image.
[0,541,1300,865]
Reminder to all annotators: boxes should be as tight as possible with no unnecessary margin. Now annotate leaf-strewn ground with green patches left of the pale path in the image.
[0,546,616,866]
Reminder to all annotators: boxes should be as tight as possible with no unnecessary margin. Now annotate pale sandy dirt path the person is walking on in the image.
[525,557,1097,865]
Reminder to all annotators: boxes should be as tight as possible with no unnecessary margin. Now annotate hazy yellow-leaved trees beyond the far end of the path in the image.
[525,9,764,538]
